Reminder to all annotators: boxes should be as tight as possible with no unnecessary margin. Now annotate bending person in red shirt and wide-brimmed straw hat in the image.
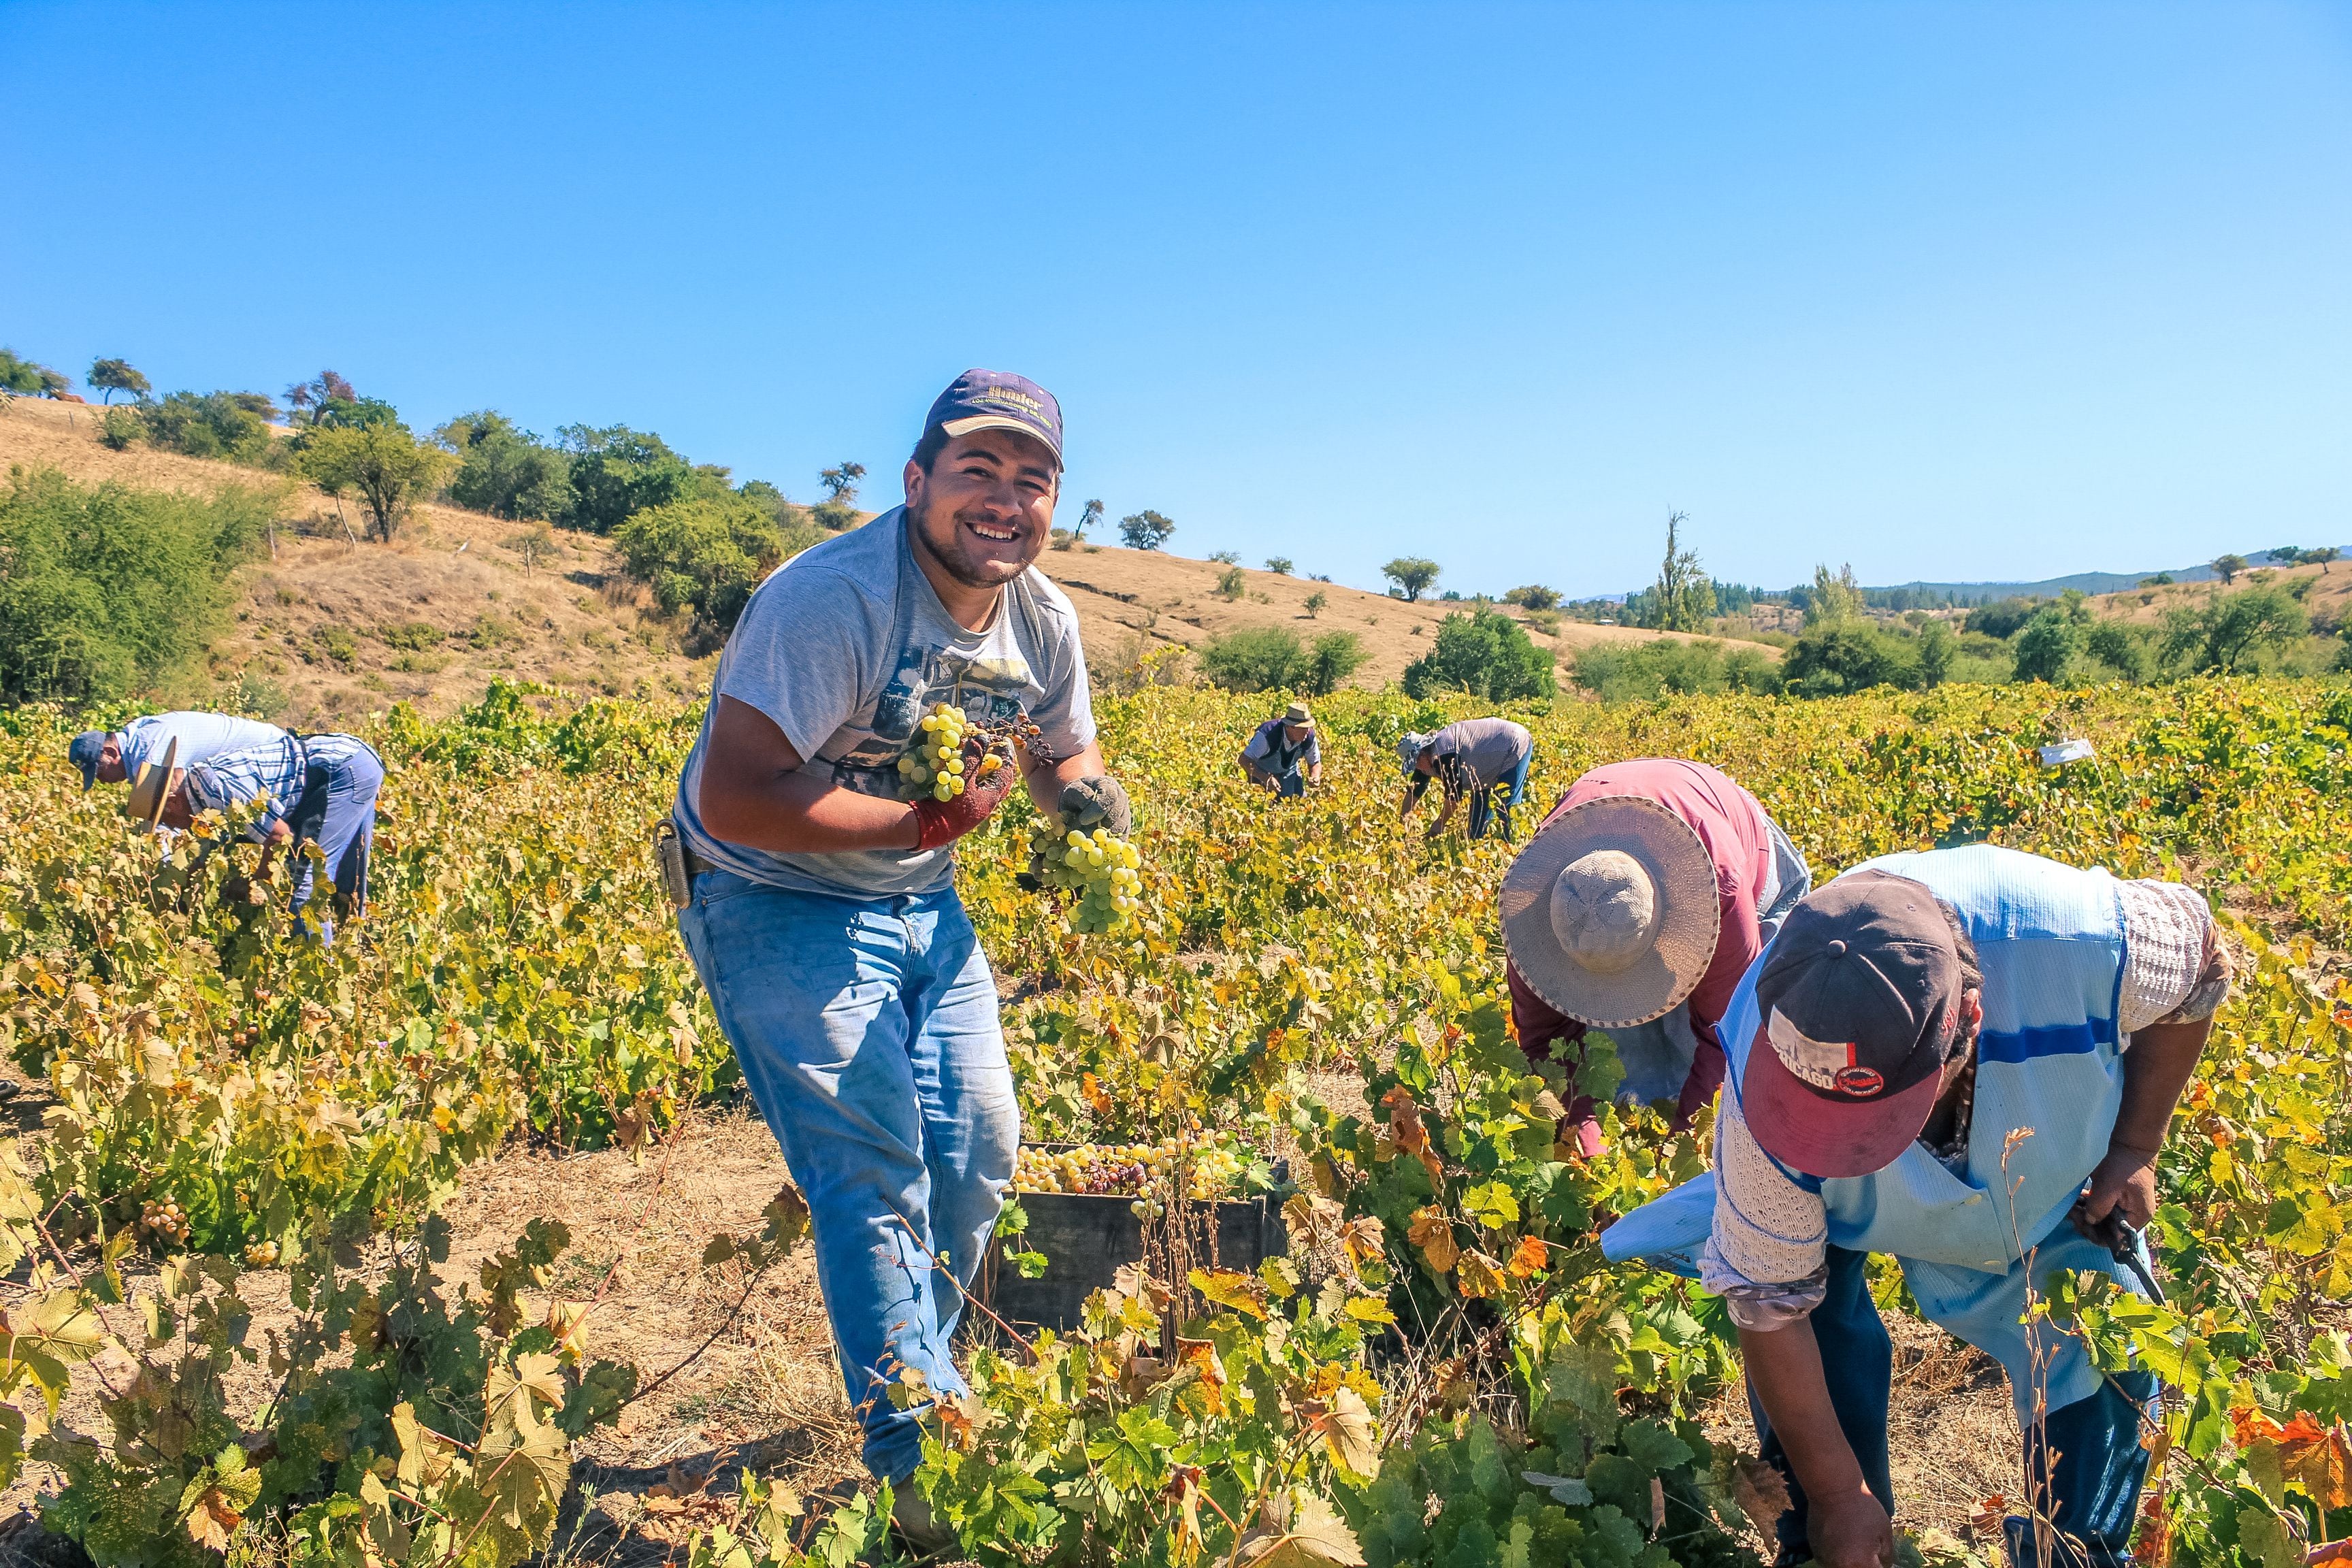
[1503,757,1814,1159]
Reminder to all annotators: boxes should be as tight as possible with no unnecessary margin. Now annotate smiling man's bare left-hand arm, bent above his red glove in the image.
[696,696,917,855]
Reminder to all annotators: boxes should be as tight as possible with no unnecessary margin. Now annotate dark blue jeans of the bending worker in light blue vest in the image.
[1748,1246,2157,1568]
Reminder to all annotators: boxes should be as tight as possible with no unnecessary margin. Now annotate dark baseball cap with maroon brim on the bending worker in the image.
[1740,872,1966,1175]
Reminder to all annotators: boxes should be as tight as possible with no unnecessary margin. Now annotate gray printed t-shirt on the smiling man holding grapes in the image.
[672,508,1094,898]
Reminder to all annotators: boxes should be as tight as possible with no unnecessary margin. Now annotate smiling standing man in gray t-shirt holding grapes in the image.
[666,372,1134,1544]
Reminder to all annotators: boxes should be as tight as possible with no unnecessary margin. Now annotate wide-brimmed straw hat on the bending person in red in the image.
[1503,795,1724,1030]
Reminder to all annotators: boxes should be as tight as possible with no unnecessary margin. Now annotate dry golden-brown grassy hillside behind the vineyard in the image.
[0,399,1740,724]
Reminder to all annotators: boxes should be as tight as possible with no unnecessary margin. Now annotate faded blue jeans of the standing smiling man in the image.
[677,870,1021,1481]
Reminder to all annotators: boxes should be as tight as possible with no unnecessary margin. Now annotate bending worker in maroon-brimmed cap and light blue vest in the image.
[1602,844,2230,1568]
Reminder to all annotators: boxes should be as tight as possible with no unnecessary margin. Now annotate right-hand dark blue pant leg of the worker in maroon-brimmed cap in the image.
[2006,1371,2157,1568]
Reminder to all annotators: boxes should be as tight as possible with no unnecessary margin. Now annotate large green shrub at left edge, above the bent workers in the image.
[0,468,275,703]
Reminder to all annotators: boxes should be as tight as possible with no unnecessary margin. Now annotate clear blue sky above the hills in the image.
[0,2,2352,592]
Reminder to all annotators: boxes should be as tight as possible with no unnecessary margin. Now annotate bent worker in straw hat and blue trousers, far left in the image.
[154,734,383,943]
